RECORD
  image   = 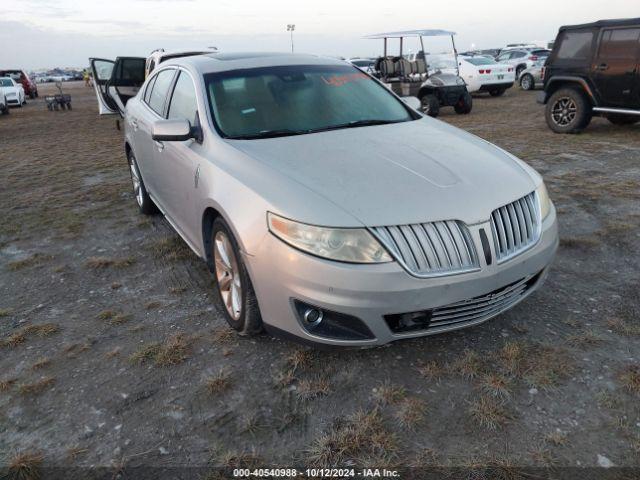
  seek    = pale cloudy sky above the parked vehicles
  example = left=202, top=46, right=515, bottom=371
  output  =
left=0, top=0, right=639, bottom=69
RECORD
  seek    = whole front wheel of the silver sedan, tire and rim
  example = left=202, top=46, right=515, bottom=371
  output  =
left=209, top=217, right=262, bottom=335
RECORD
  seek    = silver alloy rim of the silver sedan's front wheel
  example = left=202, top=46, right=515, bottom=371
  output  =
left=213, top=232, right=242, bottom=320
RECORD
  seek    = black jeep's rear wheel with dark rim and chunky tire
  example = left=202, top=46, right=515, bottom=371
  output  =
left=545, top=88, right=593, bottom=133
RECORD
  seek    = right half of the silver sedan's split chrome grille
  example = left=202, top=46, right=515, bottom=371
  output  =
left=491, top=192, right=540, bottom=262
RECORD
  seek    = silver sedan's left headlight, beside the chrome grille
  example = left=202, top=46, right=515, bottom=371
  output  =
left=267, top=212, right=393, bottom=263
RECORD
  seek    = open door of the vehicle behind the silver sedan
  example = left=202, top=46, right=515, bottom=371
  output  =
left=89, top=57, right=146, bottom=116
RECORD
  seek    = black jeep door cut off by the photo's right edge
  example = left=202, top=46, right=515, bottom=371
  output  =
left=592, top=27, right=640, bottom=108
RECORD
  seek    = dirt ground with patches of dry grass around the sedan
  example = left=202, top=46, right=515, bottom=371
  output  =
left=0, top=79, right=640, bottom=478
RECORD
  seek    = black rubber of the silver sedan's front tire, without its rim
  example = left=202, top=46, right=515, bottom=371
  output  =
left=210, top=217, right=263, bottom=336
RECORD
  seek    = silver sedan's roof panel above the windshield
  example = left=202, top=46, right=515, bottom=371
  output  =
left=162, top=52, right=350, bottom=74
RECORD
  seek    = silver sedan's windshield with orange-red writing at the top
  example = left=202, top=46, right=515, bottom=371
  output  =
left=204, top=65, right=418, bottom=139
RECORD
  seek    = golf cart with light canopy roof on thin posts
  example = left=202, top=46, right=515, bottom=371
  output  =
left=364, top=30, right=473, bottom=117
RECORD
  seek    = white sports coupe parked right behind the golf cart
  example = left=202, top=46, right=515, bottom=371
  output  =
left=427, top=55, right=516, bottom=97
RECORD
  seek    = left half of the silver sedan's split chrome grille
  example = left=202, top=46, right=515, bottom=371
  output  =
left=372, top=220, right=479, bottom=277
